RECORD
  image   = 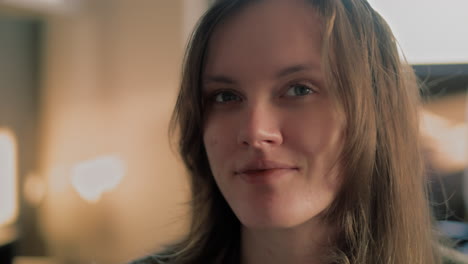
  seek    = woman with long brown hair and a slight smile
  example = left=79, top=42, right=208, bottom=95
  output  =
left=133, top=0, right=462, bottom=264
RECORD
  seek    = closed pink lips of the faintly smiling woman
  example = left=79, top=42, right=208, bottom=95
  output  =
left=235, top=159, right=299, bottom=183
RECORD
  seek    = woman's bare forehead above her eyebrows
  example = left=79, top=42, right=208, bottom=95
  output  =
left=204, top=0, right=322, bottom=78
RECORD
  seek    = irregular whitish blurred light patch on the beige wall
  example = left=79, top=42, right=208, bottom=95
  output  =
left=71, top=156, right=126, bottom=203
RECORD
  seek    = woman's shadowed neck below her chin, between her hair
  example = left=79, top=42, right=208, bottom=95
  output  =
left=241, top=218, right=333, bottom=264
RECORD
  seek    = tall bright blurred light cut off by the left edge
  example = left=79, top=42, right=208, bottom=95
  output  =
left=0, top=129, right=18, bottom=226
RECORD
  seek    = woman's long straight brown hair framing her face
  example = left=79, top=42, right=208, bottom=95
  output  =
left=165, top=0, right=440, bottom=264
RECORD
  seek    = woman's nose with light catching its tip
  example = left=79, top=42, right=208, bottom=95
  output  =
left=237, top=102, right=283, bottom=148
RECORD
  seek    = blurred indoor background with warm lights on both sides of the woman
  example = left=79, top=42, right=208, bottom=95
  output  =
left=0, top=0, right=468, bottom=264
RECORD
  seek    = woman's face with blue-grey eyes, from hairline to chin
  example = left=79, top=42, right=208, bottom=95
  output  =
left=203, top=0, right=345, bottom=228
